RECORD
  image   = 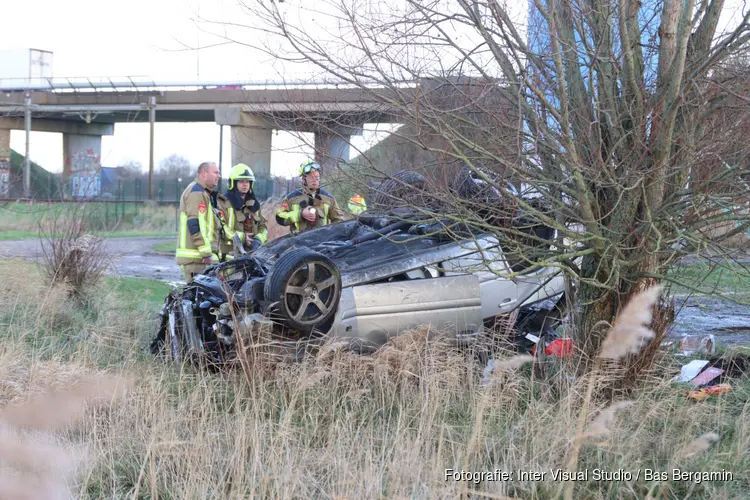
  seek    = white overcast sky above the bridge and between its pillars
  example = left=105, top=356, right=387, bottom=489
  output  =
left=0, top=0, right=742, bottom=179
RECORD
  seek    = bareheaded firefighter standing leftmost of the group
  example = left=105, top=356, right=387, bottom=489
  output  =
left=175, top=162, right=219, bottom=281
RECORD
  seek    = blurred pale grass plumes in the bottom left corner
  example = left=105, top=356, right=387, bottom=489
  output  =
left=0, top=351, right=128, bottom=500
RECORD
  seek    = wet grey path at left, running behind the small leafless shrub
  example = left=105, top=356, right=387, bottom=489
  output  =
left=0, top=238, right=182, bottom=283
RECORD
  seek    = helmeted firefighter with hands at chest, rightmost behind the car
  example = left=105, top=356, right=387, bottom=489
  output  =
left=276, top=161, right=343, bottom=233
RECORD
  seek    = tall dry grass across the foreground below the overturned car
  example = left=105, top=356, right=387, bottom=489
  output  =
left=0, top=263, right=750, bottom=499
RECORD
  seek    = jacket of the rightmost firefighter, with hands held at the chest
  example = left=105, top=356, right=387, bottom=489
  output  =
left=276, top=188, right=344, bottom=233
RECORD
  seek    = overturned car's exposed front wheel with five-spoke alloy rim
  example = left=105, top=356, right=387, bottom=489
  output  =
left=263, top=248, right=341, bottom=332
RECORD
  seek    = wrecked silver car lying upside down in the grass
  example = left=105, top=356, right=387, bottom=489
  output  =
left=151, top=199, right=576, bottom=365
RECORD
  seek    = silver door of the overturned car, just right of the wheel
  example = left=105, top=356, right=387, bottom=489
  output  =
left=332, top=274, right=482, bottom=351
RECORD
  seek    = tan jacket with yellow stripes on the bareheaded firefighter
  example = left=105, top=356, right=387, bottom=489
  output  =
left=175, top=179, right=219, bottom=266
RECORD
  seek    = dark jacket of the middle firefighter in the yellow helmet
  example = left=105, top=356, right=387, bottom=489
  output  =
left=217, top=190, right=268, bottom=260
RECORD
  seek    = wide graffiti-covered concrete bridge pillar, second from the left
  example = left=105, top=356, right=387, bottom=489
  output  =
left=62, top=134, right=102, bottom=198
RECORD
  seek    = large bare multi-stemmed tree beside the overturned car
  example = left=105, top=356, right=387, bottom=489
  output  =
left=207, top=0, right=750, bottom=352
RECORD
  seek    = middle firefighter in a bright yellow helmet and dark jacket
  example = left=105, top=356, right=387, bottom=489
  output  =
left=217, top=163, right=268, bottom=260
